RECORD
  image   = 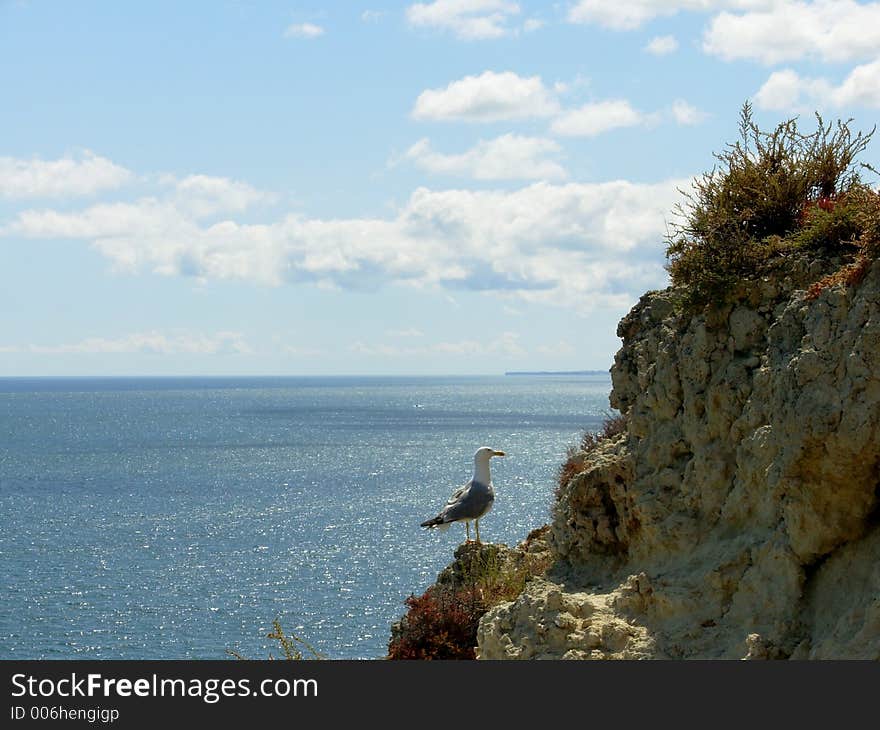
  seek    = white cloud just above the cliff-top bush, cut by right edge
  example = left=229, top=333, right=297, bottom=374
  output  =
left=755, top=60, right=880, bottom=112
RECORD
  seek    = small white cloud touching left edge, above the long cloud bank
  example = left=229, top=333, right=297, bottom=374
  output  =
left=0, top=150, right=132, bottom=199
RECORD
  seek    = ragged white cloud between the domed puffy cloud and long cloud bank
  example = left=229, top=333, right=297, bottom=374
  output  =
left=405, top=134, right=566, bottom=180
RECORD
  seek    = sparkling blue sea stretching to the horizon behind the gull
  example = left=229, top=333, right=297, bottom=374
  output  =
left=0, top=375, right=611, bottom=659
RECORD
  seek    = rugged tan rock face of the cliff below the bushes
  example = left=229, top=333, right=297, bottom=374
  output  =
left=478, top=262, right=880, bottom=659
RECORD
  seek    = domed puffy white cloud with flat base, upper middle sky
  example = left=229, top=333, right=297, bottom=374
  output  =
left=412, top=71, right=559, bottom=122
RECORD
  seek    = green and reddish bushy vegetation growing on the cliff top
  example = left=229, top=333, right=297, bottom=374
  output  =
left=666, top=103, right=880, bottom=306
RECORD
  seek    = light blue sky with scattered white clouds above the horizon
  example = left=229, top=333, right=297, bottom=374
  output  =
left=0, top=0, right=880, bottom=375
